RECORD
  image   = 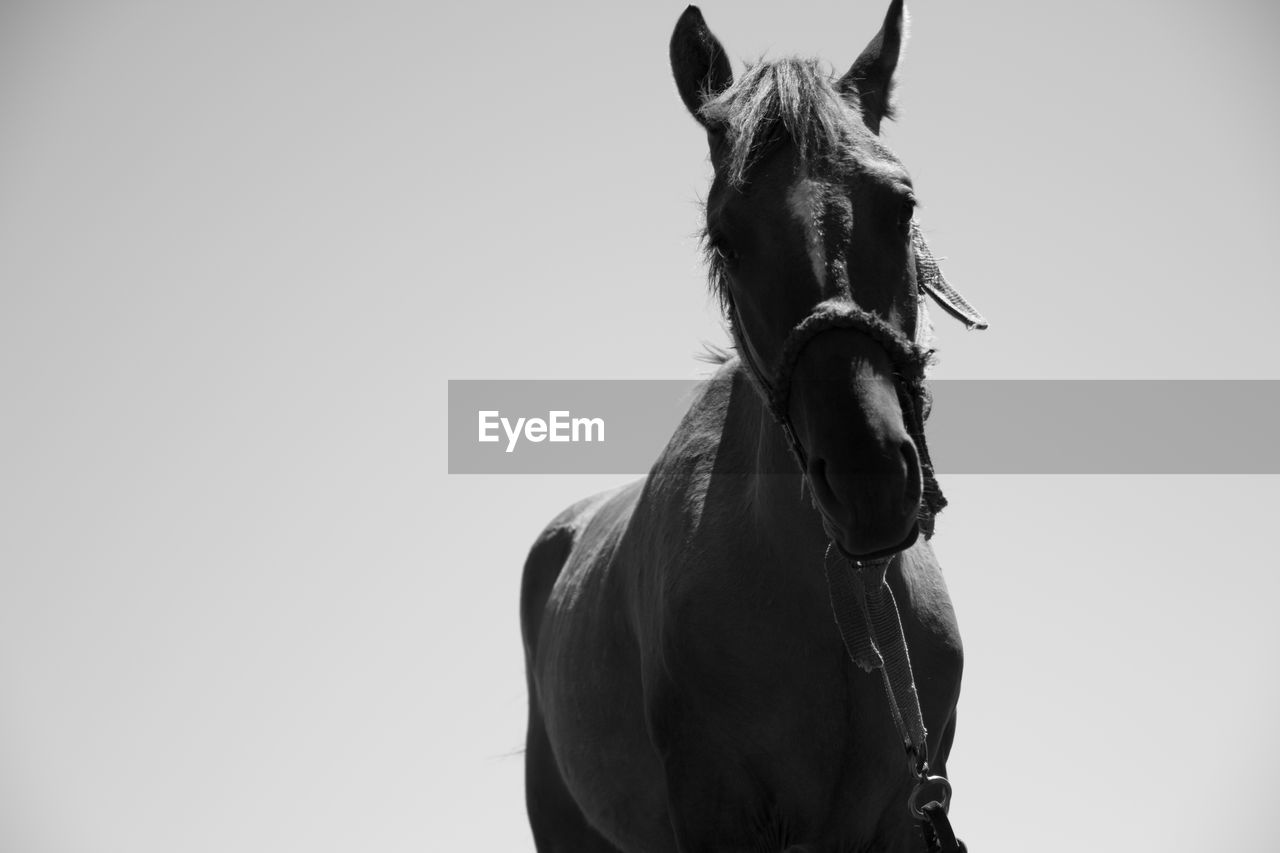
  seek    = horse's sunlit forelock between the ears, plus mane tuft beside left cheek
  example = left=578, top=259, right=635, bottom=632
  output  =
left=699, top=56, right=861, bottom=311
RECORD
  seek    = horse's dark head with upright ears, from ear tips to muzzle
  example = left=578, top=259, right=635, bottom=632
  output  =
left=671, top=0, right=977, bottom=557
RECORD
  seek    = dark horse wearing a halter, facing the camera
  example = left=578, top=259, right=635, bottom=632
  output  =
left=520, top=0, right=986, bottom=853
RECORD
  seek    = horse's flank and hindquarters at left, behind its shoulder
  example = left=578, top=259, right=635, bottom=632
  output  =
left=521, top=482, right=673, bottom=850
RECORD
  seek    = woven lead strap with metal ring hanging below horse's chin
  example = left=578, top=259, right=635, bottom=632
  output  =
left=824, top=543, right=965, bottom=853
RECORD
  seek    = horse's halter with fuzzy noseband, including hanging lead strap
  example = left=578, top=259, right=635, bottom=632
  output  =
left=730, top=220, right=987, bottom=853
